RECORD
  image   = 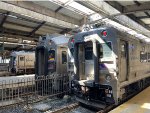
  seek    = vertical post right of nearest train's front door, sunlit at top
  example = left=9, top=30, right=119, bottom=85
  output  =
left=93, top=40, right=99, bottom=83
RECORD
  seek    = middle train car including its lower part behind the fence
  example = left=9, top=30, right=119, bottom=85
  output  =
left=35, top=35, right=69, bottom=93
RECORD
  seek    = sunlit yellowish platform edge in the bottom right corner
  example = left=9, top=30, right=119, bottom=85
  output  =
left=109, top=87, right=150, bottom=113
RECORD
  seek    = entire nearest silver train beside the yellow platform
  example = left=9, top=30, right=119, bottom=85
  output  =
left=72, top=26, right=150, bottom=109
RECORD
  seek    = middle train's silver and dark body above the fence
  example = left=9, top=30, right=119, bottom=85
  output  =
left=36, top=35, right=69, bottom=76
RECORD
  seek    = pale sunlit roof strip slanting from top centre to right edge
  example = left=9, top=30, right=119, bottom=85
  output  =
left=77, top=0, right=150, bottom=37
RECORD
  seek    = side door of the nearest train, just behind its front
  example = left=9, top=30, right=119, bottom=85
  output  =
left=120, top=40, right=128, bottom=82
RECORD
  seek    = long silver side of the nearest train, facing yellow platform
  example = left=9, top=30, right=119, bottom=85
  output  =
left=117, top=33, right=150, bottom=103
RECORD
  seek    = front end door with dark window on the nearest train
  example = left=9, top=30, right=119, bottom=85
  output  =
left=84, top=42, right=94, bottom=80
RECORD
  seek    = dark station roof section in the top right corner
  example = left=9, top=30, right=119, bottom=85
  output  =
left=106, top=0, right=150, bottom=34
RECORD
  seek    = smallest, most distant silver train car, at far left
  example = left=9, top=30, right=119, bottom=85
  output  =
left=9, top=51, right=35, bottom=74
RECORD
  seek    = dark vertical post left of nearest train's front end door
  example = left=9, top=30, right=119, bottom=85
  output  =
left=74, top=44, right=79, bottom=80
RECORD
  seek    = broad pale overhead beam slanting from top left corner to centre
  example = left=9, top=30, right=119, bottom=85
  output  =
left=0, top=1, right=80, bottom=28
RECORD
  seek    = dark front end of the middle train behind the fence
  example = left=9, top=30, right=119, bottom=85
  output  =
left=35, top=36, right=56, bottom=77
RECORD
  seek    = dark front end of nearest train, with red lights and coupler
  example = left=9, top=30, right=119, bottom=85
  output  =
left=72, top=27, right=117, bottom=109
